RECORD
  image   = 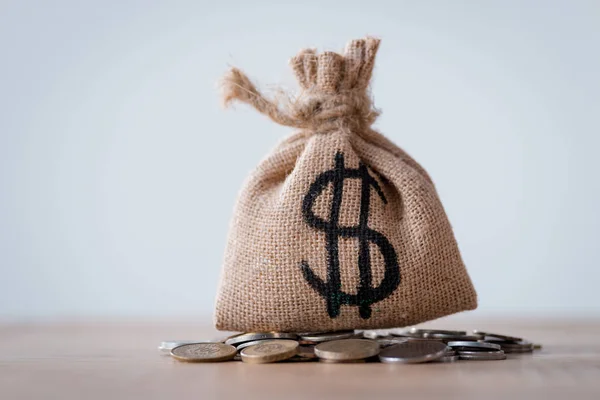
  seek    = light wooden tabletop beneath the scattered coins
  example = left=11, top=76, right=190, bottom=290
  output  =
left=0, top=318, right=600, bottom=400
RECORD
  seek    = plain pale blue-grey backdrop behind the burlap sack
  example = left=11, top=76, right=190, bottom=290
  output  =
left=0, top=0, right=600, bottom=319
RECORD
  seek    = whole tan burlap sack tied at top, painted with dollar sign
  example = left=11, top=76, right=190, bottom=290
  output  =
left=215, top=38, right=477, bottom=332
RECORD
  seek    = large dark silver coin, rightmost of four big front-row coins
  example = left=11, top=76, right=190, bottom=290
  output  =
left=379, top=340, right=448, bottom=364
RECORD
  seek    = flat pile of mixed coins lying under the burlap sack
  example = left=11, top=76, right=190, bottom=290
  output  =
left=158, top=328, right=541, bottom=364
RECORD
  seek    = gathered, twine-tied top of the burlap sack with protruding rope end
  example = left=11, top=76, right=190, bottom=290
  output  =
left=223, top=38, right=380, bottom=133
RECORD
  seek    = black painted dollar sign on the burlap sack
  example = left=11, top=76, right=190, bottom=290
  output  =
left=300, top=152, right=400, bottom=319
